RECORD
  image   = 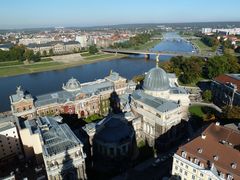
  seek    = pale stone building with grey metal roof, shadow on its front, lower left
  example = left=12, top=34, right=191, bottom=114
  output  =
left=17, top=116, right=87, bottom=180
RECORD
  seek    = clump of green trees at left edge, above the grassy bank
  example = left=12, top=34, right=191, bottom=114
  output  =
left=0, top=45, right=41, bottom=61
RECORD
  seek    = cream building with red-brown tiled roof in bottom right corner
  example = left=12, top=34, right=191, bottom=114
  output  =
left=172, top=122, right=240, bottom=180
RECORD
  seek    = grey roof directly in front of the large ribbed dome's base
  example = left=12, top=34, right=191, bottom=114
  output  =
left=132, top=90, right=179, bottom=112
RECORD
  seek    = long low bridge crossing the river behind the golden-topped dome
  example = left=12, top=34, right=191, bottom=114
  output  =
left=102, top=49, right=210, bottom=59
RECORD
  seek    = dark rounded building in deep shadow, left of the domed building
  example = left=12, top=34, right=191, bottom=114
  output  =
left=83, top=113, right=137, bottom=172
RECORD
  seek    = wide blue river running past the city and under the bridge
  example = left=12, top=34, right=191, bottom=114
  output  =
left=0, top=32, right=193, bottom=112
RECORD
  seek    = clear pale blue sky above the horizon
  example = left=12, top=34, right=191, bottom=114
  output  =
left=0, top=0, right=240, bottom=29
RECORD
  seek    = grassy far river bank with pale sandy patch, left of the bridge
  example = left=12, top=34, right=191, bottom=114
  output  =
left=0, top=40, right=160, bottom=78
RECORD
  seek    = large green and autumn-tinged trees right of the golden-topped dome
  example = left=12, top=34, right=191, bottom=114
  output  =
left=161, top=54, right=240, bottom=84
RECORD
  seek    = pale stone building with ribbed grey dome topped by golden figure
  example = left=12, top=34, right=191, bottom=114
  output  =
left=127, top=57, right=190, bottom=146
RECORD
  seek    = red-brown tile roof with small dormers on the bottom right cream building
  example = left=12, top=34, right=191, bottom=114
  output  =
left=177, top=123, right=240, bottom=179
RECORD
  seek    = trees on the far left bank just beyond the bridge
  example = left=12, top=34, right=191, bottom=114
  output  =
left=111, top=33, right=152, bottom=48
